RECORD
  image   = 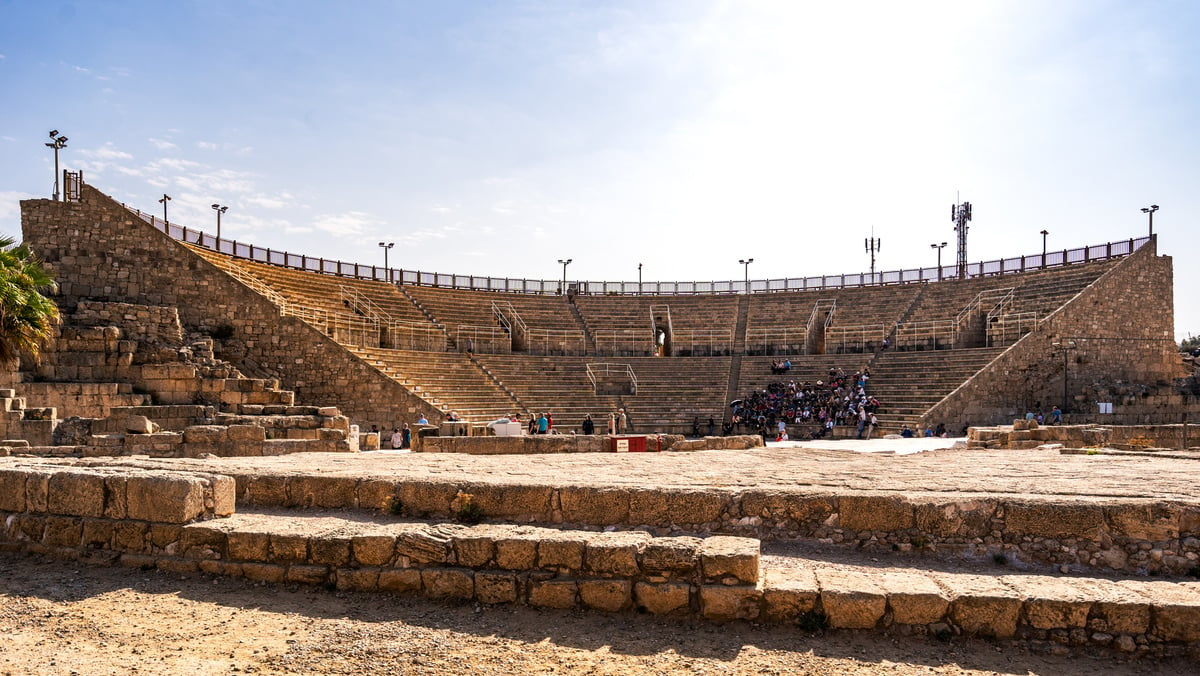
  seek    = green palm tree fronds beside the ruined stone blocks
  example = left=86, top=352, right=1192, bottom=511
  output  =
left=0, top=237, right=61, bottom=364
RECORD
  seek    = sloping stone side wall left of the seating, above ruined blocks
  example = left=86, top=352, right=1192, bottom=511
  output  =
left=22, top=185, right=443, bottom=429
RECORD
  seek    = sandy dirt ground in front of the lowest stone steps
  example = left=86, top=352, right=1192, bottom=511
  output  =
left=0, top=554, right=1198, bottom=676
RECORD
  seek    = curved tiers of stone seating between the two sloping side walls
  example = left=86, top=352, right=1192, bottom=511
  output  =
left=180, top=245, right=1120, bottom=431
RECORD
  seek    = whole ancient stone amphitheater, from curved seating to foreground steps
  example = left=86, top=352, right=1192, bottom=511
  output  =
left=0, top=185, right=1200, bottom=654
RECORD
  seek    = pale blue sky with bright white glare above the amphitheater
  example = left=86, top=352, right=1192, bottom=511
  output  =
left=0, top=0, right=1200, bottom=336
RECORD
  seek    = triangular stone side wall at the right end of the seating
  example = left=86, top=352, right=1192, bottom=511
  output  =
left=920, top=240, right=1183, bottom=429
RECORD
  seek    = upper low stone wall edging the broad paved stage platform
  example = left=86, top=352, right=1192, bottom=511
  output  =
left=211, top=473, right=1200, bottom=575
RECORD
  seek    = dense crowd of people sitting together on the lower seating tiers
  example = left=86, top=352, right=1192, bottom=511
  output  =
left=726, top=364, right=880, bottom=439
